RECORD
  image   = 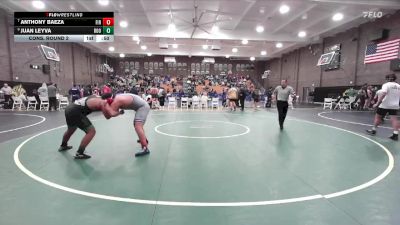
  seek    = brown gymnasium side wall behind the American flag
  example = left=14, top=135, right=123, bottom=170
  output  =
left=264, top=11, right=400, bottom=97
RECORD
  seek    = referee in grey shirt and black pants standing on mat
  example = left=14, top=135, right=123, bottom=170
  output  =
left=274, top=80, right=294, bottom=130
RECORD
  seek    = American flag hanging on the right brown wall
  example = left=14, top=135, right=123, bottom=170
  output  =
left=364, top=39, right=400, bottom=64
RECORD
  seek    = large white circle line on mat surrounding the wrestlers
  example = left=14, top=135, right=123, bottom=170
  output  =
left=13, top=114, right=394, bottom=207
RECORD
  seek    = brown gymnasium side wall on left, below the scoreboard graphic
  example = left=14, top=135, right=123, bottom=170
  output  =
left=0, top=9, right=110, bottom=93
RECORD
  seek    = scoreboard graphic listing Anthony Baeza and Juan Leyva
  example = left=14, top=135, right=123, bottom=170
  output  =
left=14, top=12, right=114, bottom=42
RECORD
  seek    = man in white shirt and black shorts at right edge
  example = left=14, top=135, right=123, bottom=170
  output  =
left=367, top=74, right=400, bottom=141
